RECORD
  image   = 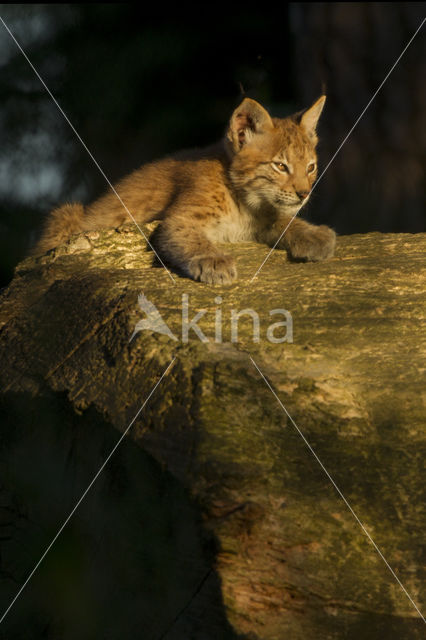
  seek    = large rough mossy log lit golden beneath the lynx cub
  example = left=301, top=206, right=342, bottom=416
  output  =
left=0, top=222, right=426, bottom=640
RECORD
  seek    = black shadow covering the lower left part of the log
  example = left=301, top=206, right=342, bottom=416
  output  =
left=0, top=393, right=238, bottom=640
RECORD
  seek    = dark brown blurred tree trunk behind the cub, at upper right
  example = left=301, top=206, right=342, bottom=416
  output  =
left=290, top=2, right=426, bottom=232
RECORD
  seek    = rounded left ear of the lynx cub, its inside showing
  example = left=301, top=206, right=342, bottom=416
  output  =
left=226, top=98, right=274, bottom=151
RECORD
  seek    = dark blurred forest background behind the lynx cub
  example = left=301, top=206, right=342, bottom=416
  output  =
left=0, top=2, right=426, bottom=285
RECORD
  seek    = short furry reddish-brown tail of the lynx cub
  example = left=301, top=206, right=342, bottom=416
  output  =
left=32, top=204, right=84, bottom=255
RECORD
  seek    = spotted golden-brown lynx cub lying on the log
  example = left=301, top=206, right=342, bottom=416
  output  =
left=36, top=96, right=336, bottom=284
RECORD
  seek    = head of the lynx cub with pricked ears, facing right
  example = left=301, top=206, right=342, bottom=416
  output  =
left=226, top=96, right=325, bottom=215
